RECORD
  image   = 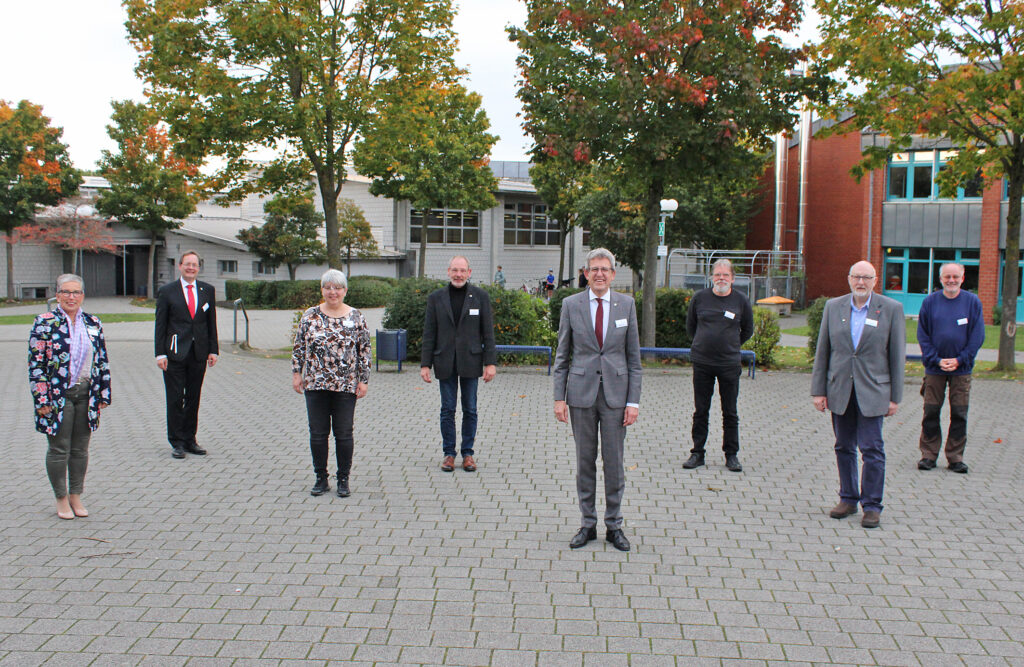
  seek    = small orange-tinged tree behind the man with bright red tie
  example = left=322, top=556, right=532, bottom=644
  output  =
left=96, top=100, right=199, bottom=297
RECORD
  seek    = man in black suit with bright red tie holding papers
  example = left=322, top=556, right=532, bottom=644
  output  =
left=155, top=250, right=219, bottom=459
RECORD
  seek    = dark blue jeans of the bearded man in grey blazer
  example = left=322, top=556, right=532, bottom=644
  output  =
left=833, top=390, right=886, bottom=512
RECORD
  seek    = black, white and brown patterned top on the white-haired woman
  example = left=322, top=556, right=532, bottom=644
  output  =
left=292, top=305, right=371, bottom=393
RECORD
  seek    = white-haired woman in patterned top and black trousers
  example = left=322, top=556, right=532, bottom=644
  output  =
left=292, top=268, right=370, bottom=498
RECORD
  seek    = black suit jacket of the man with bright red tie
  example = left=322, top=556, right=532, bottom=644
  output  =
left=154, top=280, right=219, bottom=362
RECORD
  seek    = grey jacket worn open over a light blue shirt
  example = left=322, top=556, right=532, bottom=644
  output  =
left=811, top=294, right=906, bottom=417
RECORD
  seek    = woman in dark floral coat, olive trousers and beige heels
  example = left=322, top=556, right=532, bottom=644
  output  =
left=29, top=274, right=111, bottom=518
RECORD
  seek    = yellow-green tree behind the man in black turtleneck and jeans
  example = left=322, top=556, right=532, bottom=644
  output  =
left=353, top=79, right=498, bottom=278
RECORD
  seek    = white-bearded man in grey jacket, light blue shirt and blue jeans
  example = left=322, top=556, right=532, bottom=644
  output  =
left=811, top=261, right=906, bottom=528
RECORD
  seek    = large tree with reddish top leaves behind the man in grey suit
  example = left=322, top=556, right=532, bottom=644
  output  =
left=511, top=0, right=813, bottom=345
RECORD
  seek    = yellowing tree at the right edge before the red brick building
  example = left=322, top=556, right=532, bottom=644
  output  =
left=815, top=0, right=1024, bottom=371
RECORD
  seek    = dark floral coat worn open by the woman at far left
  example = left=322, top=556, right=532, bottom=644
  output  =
left=29, top=309, right=111, bottom=435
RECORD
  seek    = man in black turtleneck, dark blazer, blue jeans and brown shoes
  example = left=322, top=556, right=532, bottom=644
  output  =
left=420, top=255, right=498, bottom=472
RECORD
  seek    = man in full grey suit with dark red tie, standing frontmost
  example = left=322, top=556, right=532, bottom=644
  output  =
left=554, top=248, right=642, bottom=551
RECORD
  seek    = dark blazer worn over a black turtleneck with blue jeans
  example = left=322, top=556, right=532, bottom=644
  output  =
left=420, top=285, right=498, bottom=380
